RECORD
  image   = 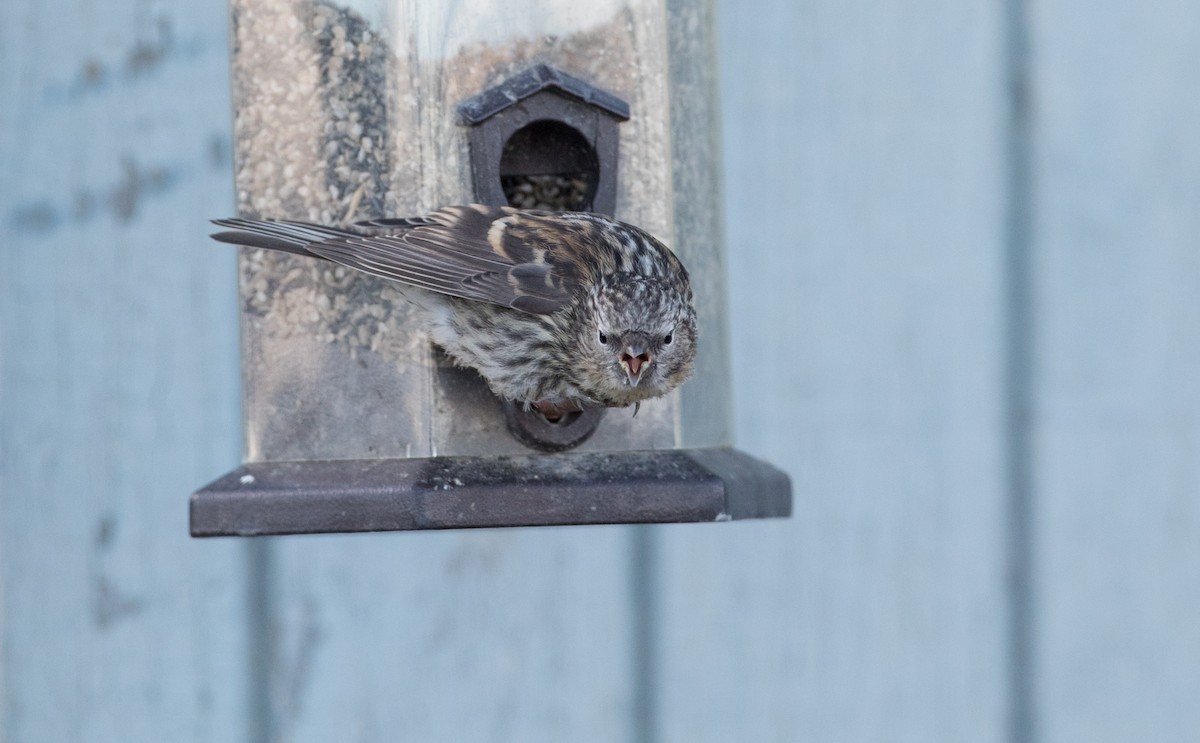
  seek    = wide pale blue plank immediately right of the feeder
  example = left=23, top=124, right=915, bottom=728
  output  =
left=656, top=1, right=1007, bottom=743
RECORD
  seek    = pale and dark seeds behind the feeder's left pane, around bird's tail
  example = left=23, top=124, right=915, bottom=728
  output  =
left=233, top=0, right=410, bottom=355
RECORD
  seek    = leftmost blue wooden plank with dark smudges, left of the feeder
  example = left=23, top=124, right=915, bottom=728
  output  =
left=0, top=0, right=250, bottom=743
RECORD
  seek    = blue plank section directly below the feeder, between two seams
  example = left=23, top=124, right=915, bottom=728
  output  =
left=259, top=528, right=635, bottom=742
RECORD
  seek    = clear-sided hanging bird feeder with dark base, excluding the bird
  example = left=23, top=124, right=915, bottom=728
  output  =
left=191, top=0, right=791, bottom=537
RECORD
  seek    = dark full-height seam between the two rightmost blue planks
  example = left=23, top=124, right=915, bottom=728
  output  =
left=1003, top=0, right=1038, bottom=743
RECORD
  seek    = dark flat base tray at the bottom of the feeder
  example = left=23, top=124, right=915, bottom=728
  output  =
left=191, top=448, right=792, bottom=537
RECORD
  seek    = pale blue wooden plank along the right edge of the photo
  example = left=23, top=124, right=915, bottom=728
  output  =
left=1030, top=0, right=1200, bottom=743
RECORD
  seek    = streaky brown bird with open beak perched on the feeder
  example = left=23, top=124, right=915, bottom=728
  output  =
left=212, top=204, right=696, bottom=420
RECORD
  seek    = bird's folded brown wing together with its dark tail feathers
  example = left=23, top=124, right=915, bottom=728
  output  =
left=214, top=205, right=576, bottom=314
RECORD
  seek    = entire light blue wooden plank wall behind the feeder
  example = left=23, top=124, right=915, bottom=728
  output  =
left=0, top=0, right=1200, bottom=743
